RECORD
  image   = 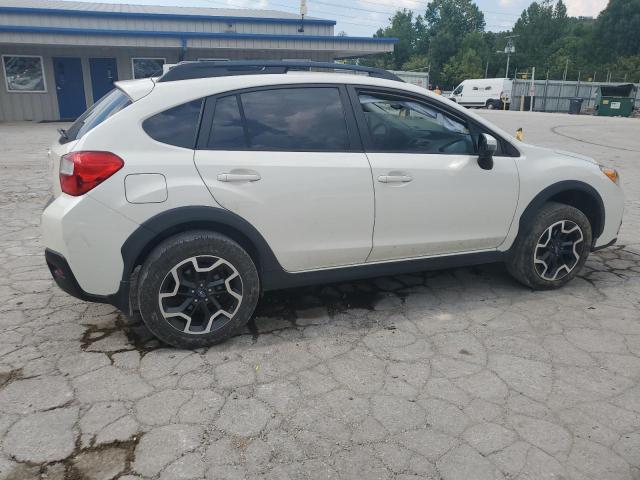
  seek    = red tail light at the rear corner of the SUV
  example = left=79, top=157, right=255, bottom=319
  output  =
left=60, top=152, right=124, bottom=197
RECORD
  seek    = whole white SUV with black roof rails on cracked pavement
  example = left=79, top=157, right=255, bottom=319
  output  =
left=42, top=62, right=624, bottom=348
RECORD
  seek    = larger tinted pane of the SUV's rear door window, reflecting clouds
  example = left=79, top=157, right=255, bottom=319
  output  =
left=240, top=87, right=349, bottom=151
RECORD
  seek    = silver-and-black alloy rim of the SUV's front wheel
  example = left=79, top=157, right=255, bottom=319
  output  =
left=533, top=220, right=584, bottom=281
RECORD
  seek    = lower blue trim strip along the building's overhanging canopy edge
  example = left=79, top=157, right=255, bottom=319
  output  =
left=0, top=25, right=398, bottom=43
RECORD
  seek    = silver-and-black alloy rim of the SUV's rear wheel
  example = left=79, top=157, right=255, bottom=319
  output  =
left=158, top=255, right=243, bottom=334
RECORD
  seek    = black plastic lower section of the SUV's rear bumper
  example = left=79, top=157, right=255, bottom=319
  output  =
left=44, top=248, right=129, bottom=313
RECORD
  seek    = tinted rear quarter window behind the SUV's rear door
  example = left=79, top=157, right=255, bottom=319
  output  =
left=142, top=99, right=202, bottom=148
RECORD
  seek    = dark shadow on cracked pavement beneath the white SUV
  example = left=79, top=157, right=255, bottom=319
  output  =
left=105, top=264, right=526, bottom=353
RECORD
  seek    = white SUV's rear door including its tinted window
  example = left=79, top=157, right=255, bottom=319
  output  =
left=195, top=85, right=374, bottom=272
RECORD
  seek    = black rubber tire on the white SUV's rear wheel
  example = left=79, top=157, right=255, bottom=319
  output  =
left=138, top=230, right=260, bottom=349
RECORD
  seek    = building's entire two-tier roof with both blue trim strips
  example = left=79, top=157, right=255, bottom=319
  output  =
left=0, top=0, right=397, bottom=58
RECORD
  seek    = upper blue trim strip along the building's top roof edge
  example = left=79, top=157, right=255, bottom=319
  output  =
left=0, top=7, right=336, bottom=25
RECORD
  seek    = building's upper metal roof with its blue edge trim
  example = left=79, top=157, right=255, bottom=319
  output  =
left=0, top=0, right=336, bottom=25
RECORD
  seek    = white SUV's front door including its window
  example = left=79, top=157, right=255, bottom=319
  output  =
left=354, top=90, right=518, bottom=262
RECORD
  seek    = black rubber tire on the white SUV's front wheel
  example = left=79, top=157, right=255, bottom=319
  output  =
left=506, top=202, right=592, bottom=290
